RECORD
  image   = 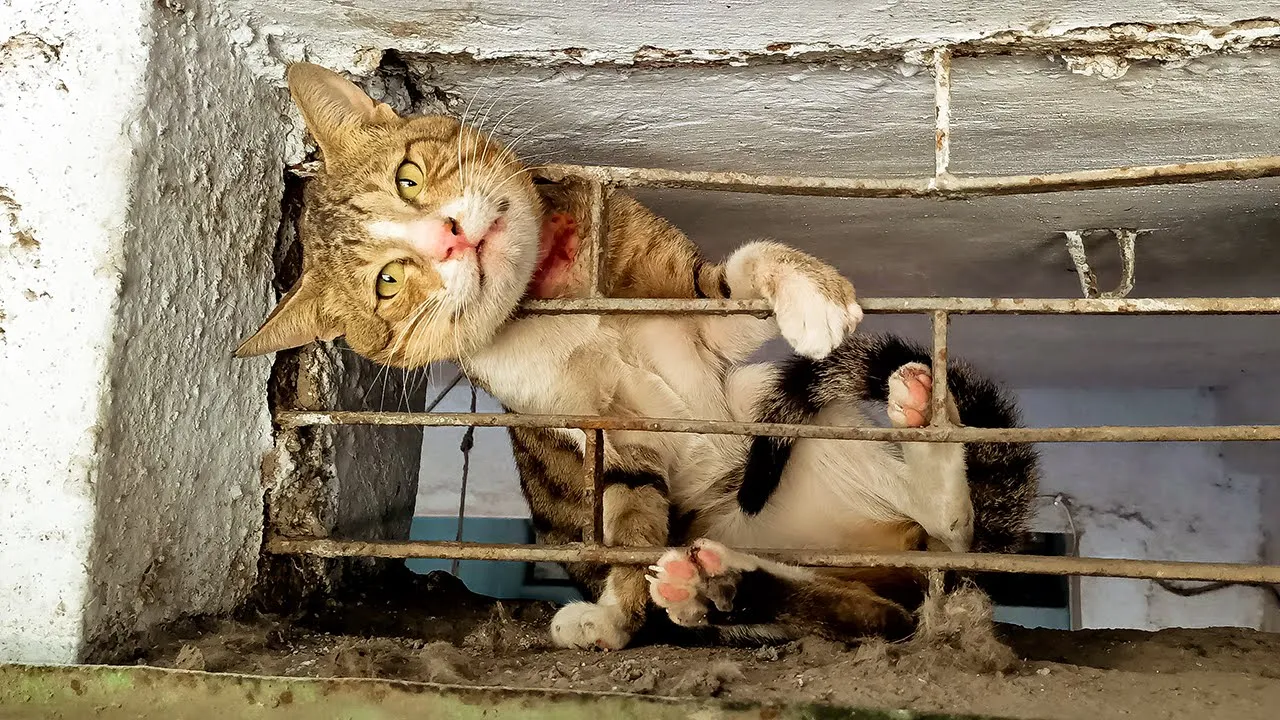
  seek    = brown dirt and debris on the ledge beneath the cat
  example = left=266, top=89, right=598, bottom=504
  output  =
left=132, top=573, right=1280, bottom=720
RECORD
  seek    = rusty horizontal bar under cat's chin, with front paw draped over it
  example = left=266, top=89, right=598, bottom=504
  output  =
left=521, top=297, right=1280, bottom=318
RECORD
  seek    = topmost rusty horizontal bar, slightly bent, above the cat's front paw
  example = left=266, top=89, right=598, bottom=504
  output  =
left=538, top=155, right=1280, bottom=199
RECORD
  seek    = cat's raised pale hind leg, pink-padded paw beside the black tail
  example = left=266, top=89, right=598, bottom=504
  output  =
left=887, top=363, right=973, bottom=552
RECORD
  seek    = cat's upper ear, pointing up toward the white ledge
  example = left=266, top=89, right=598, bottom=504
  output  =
left=285, top=63, right=397, bottom=161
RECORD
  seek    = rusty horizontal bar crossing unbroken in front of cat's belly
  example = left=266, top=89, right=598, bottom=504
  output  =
left=275, top=410, right=1280, bottom=442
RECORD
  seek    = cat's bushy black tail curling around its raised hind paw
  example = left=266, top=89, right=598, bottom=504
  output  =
left=737, top=333, right=1039, bottom=552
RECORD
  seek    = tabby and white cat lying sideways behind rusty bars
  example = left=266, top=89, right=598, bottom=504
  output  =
left=236, top=63, right=1038, bottom=648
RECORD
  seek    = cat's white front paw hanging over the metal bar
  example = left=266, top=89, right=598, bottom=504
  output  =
left=773, top=268, right=863, bottom=360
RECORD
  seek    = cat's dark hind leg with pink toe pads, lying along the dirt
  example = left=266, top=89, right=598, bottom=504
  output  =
left=649, top=539, right=914, bottom=639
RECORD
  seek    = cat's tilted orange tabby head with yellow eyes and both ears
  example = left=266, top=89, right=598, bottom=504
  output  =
left=236, top=63, right=543, bottom=368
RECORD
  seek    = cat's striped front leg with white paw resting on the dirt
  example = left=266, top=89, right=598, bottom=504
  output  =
left=552, top=458, right=669, bottom=650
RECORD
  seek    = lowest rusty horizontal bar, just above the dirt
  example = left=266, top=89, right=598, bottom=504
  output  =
left=266, top=536, right=1280, bottom=583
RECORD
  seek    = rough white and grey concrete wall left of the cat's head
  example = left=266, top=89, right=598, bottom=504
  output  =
left=0, top=0, right=283, bottom=662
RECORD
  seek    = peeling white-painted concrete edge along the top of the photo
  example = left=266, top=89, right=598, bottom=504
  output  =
left=220, top=0, right=1280, bottom=74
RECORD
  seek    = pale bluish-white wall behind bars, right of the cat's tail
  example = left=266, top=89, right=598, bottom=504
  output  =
left=1019, top=389, right=1270, bottom=629
